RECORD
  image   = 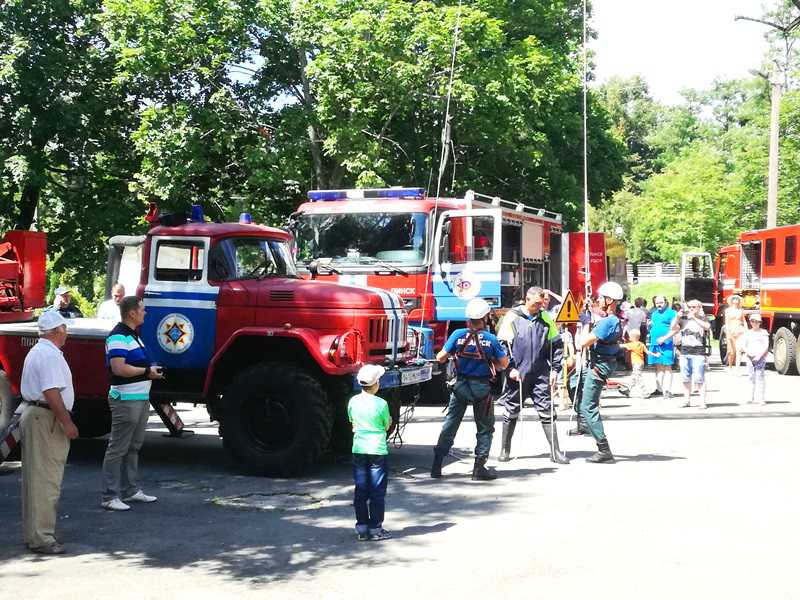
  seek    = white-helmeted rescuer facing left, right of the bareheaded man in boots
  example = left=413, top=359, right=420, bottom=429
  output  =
left=580, top=281, right=624, bottom=463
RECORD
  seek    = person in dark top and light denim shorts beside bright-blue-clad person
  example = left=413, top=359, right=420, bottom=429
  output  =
left=657, top=300, right=711, bottom=408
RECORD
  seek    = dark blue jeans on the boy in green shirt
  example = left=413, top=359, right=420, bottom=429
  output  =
left=353, top=454, right=389, bottom=533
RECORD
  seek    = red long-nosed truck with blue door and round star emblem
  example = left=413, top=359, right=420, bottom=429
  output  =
left=0, top=213, right=431, bottom=476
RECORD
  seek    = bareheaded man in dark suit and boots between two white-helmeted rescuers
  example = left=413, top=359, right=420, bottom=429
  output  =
left=498, top=287, right=569, bottom=465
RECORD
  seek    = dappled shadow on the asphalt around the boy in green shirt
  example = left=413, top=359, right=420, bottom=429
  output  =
left=0, top=438, right=532, bottom=585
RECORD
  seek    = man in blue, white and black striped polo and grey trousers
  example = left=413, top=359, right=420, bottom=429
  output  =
left=101, top=296, right=164, bottom=510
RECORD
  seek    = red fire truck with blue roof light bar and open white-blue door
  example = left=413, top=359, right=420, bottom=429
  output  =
left=290, top=188, right=626, bottom=392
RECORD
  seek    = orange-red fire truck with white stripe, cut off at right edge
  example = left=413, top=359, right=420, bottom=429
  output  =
left=684, top=225, right=800, bottom=375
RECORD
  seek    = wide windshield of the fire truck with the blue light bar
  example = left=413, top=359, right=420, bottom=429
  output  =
left=294, top=213, right=428, bottom=266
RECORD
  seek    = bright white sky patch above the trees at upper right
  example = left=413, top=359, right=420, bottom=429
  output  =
left=592, top=0, right=767, bottom=104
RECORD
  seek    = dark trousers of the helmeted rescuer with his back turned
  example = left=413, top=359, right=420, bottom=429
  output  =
left=434, top=379, right=494, bottom=458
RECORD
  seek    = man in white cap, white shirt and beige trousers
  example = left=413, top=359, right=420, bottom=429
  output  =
left=20, top=310, right=78, bottom=554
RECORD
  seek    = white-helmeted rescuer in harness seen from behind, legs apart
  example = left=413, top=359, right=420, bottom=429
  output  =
left=431, top=298, right=508, bottom=481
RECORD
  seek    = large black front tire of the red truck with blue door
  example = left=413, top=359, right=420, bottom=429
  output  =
left=222, top=363, right=333, bottom=477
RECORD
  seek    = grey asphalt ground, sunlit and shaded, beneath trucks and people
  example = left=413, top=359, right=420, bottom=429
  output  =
left=0, top=358, right=800, bottom=600
